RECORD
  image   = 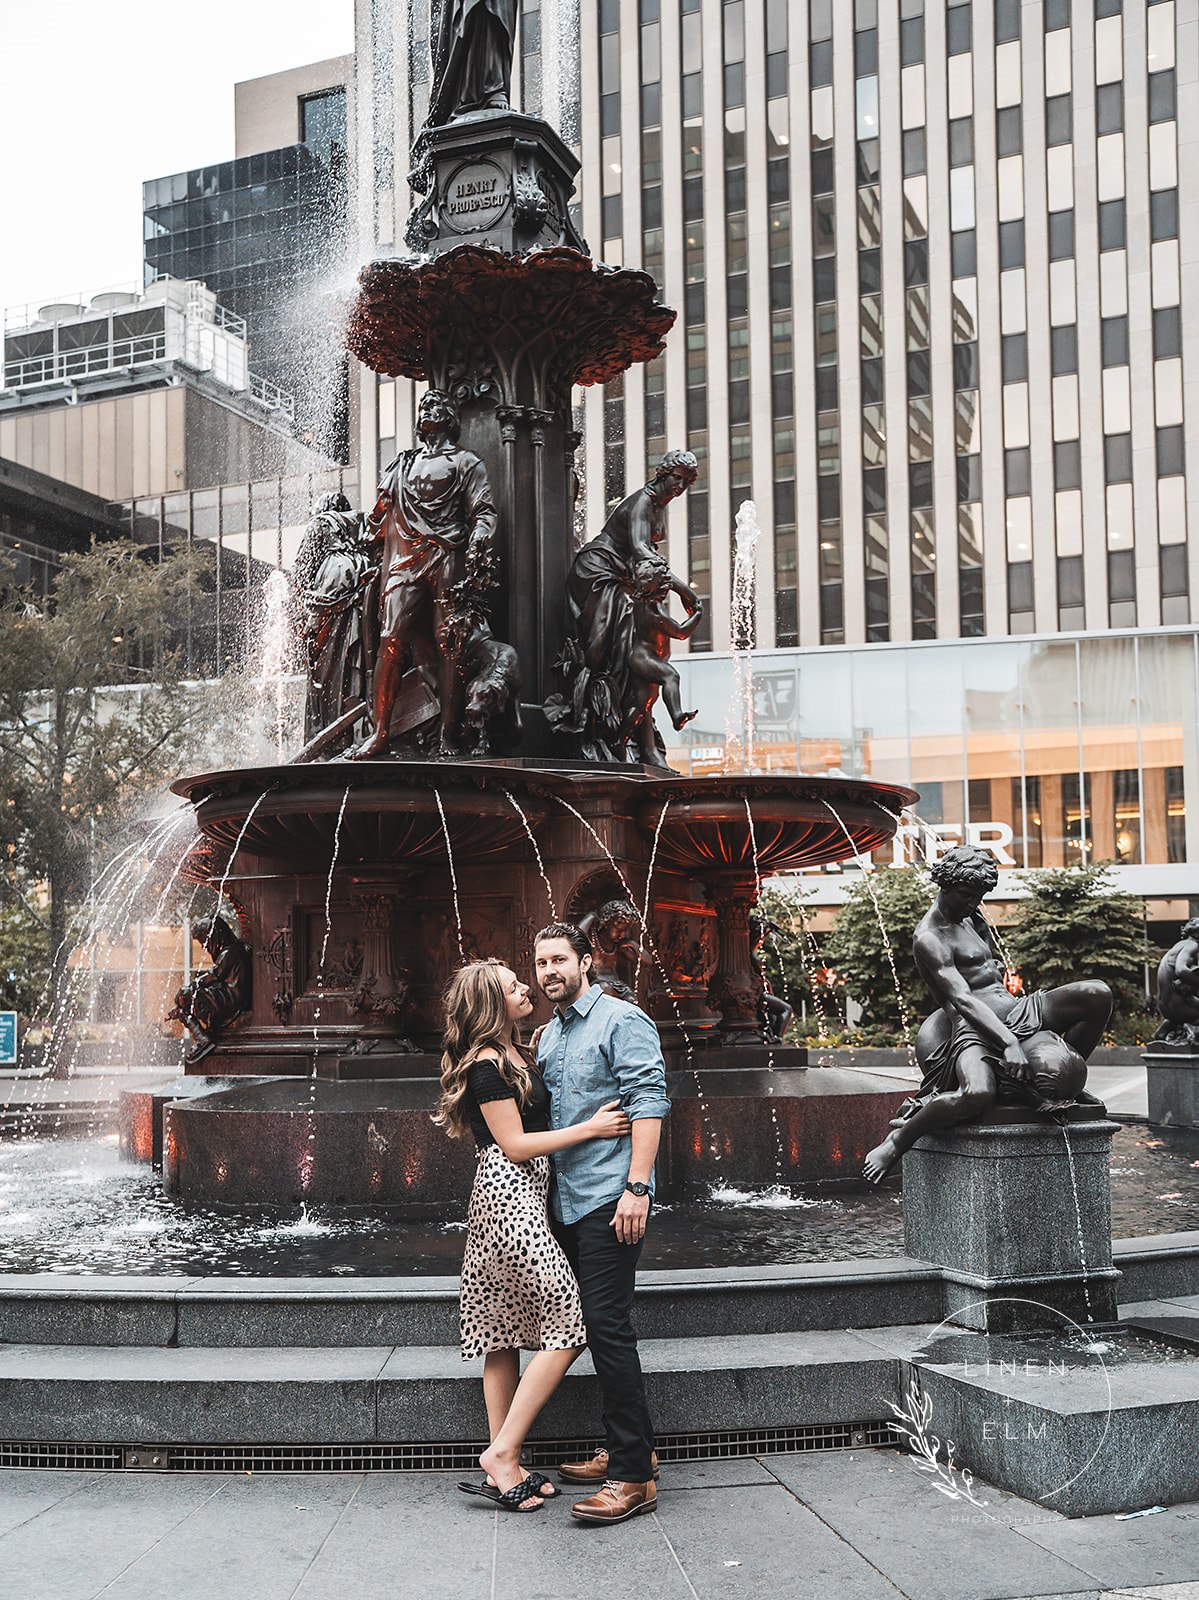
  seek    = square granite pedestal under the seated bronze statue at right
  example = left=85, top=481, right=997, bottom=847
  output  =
left=903, top=1106, right=1119, bottom=1333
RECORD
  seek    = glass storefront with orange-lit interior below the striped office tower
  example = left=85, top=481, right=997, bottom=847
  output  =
left=668, top=627, right=1199, bottom=898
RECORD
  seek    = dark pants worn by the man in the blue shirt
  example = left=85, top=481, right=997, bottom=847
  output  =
left=554, top=1200, right=653, bottom=1483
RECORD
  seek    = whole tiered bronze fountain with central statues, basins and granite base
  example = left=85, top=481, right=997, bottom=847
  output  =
left=140, top=0, right=914, bottom=1206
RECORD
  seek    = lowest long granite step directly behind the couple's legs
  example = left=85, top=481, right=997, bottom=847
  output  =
left=0, top=1330, right=901, bottom=1446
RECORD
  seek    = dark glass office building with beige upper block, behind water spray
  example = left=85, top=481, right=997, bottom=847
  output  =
left=142, top=58, right=354, bottom=461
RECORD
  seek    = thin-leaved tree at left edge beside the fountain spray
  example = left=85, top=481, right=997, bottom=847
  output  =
left=0, top=541, right=195, bottom=1004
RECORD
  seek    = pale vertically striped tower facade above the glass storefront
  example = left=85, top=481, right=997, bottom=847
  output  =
left=579, top=0, right=1199, bottom=650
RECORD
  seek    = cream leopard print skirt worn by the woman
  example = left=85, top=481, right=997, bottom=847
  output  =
left=459, top=1144, right=587, bottom=1362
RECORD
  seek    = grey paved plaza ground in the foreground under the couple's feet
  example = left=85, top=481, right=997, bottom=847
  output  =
left=0, top=1450, right=1199, bottom=1600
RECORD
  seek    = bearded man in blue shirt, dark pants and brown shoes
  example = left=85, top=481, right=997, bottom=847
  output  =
left=533, top=922, right=671, bottom=1523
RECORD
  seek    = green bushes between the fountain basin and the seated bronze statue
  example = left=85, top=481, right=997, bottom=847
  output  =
left=762, top=867, right=935, bottom=1038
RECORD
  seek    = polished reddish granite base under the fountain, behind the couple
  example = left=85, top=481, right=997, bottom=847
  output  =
left=152, top=1051, right=896, bottom=1218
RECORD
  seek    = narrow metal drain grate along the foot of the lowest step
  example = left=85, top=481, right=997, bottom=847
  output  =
left=0, top=1422, right=898, bottom=1472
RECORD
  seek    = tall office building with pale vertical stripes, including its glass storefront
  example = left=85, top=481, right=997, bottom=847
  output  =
left=357, top=0, right=1199, bottom=928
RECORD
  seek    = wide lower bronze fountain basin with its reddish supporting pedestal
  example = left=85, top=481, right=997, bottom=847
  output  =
left=173, top=760, right=912, bottom=1077
